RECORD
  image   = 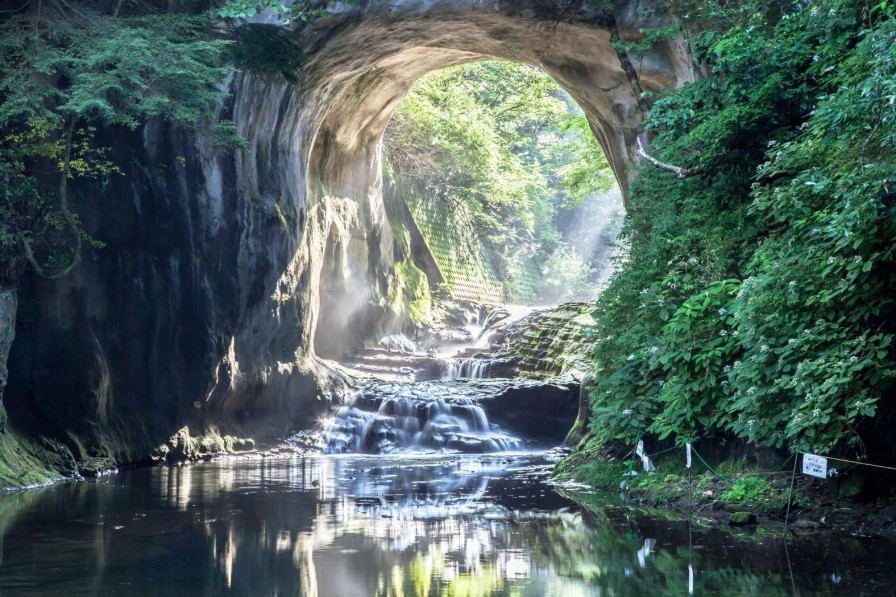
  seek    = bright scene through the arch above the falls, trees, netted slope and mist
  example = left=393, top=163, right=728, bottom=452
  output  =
left=383, top=62, right=623, bottom=306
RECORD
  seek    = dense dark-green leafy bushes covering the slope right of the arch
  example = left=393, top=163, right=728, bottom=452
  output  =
left=591, top=0, right=896, bottom=452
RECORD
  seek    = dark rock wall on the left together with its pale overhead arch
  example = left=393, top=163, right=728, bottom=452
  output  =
left=5, top=0, right=693, bottom=459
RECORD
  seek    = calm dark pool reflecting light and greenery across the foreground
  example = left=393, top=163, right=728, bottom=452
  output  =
left=0, top=454, right=896, bottom=597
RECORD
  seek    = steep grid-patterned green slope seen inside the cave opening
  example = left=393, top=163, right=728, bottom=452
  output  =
left=404, top=193, right=504, bottom=303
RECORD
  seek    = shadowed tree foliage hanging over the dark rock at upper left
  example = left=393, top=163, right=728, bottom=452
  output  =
left=0, top=8, right=234, bottom=278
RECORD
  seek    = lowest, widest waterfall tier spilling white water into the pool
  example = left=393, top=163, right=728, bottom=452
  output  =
left=325, top=383, right=523, bottom=454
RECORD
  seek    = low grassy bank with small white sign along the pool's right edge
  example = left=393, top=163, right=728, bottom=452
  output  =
left=553, top=438, right=896, bottom=536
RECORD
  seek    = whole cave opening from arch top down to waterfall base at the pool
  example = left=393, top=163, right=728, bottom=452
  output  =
left=316, top=61, right=624, bottom=453
